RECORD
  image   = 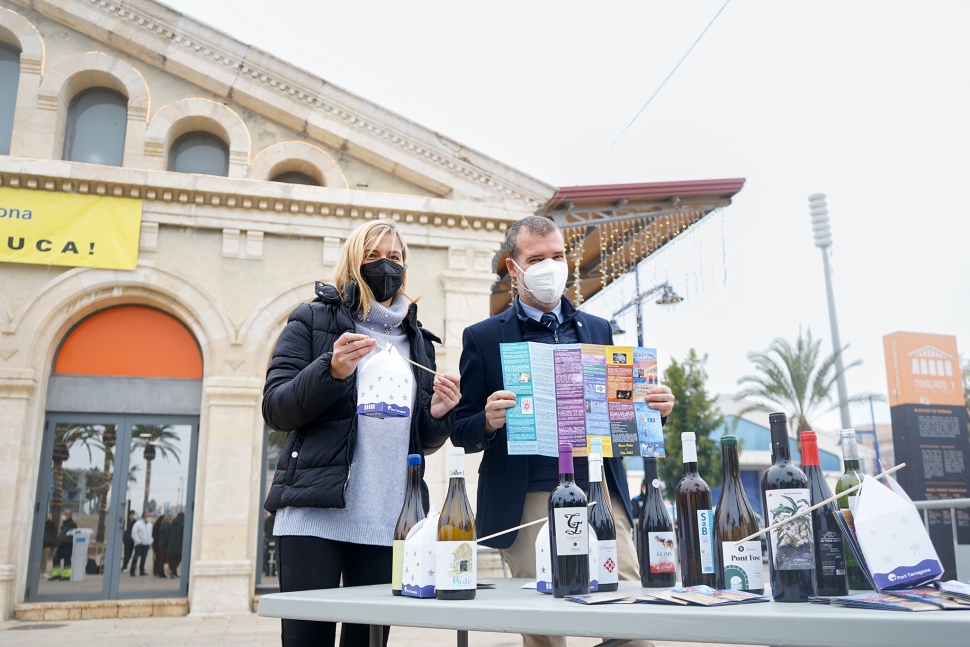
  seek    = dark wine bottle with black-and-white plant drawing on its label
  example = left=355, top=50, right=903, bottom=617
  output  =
left=761, top=413, right=815, bottom=602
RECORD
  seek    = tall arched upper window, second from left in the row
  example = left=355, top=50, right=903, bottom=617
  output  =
left=64, top=88, right=128, bottom=166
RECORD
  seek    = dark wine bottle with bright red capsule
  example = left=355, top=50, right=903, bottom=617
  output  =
left=802, top=431, right=849, bottom=595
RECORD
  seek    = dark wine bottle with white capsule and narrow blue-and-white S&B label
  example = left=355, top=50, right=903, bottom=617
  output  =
left=676, top=431, right=717, bottom=587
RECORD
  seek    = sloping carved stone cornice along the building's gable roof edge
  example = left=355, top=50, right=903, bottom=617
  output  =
left=13, top=0, right=554, bottom=211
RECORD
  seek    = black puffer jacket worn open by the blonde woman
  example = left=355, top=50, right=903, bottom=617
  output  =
left=263, top=282, right=455, bottom=512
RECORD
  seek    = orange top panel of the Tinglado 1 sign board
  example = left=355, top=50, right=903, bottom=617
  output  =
left=882, top=332, right=964, bottom=407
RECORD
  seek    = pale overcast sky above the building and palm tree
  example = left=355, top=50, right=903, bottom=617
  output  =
left=166, top=0, right=970, bottom=436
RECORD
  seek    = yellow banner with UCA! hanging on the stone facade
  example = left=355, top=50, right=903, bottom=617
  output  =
left=0, top=189, right=142, bottom=270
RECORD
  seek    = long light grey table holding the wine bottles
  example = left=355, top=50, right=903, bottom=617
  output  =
left=258, top=579, right=970, bottom=647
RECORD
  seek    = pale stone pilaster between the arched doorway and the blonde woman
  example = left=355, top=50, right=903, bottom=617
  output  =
left=189, top=376, right=263, bottom=613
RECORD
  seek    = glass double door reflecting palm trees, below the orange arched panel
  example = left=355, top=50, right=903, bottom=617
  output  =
left=26, top=414, right=198, bottom=601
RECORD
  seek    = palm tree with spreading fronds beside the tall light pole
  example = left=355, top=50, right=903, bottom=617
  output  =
left=738, top=330, right=883, bottom=447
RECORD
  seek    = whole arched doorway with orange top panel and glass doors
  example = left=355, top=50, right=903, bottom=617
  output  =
left=26, top=305, right=202, bottom=601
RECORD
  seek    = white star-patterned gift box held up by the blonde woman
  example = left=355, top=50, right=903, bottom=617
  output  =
left=357, top=346, right=414, bottom=418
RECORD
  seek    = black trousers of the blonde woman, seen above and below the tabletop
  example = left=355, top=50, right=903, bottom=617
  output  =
left=276, top=536, right=392, bottom=647
